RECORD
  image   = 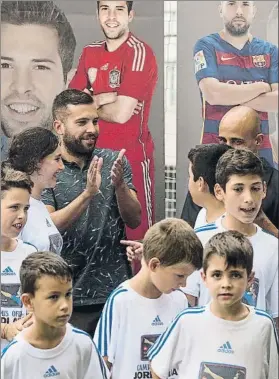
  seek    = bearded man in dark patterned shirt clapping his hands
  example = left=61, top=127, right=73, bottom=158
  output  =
left=43, top=89, right=141, bottom=336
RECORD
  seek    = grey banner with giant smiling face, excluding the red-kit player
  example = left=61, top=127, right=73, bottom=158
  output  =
left=1, top=0, right=165, bottom=223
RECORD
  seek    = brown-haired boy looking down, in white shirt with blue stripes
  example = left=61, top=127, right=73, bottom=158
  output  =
left=94, top=218, right=203, bottom=379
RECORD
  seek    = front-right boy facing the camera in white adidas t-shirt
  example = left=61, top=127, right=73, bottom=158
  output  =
left=148, top=231, right=278, bottom=379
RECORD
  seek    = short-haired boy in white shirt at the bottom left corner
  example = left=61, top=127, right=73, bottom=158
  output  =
left=1, top=252, right=108, bottom=379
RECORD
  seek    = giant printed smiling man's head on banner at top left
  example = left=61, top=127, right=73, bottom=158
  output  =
left=1, top=1, right=76, bottom=159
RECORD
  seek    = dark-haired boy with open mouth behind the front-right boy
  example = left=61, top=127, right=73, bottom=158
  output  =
left=183, top=149, right=278, bottom=330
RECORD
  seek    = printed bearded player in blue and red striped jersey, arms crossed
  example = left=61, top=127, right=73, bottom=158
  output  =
left=194, top=1, right=278, bottom=168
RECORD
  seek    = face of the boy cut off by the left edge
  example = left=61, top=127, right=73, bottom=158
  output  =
left=1, top=188, right=30, bottom=238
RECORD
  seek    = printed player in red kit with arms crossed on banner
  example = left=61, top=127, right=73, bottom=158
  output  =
left=70, top=1, right=157, bottom=243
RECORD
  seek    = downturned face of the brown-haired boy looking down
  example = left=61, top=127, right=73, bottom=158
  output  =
left=149, top=262, right=195, bottom=294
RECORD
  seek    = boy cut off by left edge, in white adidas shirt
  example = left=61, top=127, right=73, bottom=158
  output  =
left=1, top=163, right=37, bottom=350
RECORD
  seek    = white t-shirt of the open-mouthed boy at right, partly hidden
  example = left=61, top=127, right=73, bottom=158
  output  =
left=182, top=216, right=278, bottom=318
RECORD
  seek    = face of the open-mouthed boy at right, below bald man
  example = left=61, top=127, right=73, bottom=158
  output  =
left=215, top=175, right=266, bottom=224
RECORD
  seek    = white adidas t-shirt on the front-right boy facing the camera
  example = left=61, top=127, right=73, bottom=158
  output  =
left=151, top=304, right=278, bottom=379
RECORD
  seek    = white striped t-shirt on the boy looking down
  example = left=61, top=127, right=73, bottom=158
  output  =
left=94, top=281, right=188, bottom=379
